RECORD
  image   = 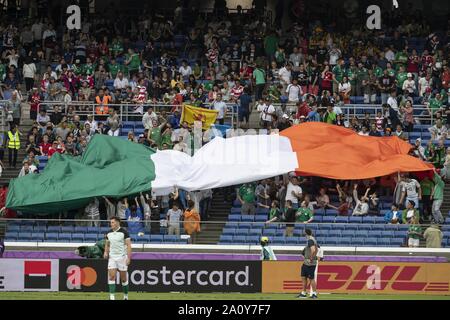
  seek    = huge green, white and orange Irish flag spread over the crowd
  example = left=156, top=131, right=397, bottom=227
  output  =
left=6, top=123, right=433, bottom=213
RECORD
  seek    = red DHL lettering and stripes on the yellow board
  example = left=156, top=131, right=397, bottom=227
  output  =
left=283, top=265, right=449, bottom=292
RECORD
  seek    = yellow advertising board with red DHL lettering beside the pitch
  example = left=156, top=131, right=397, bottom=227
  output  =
left=262, top=261, right=450, bottom=295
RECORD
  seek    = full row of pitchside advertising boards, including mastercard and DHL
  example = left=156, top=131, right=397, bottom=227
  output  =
left=0, top=258, right=450, bottom=295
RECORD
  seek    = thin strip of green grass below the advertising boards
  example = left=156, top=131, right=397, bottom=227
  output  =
left=0, top=292, right=450, bottom=300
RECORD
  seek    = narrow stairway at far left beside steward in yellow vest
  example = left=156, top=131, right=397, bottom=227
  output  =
left=0, top=103, right=33, bottom=185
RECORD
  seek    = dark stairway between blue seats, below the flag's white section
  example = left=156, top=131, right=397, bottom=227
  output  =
left=196, top=190, right=231, bottom=244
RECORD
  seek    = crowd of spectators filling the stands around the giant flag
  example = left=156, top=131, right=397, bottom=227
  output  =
left=0, top=1, right=450, bottom=246
